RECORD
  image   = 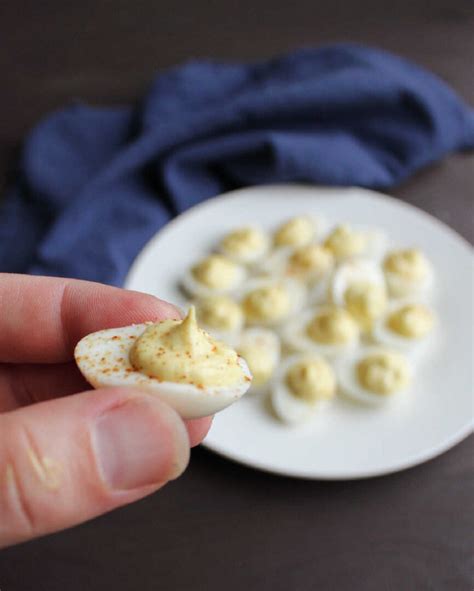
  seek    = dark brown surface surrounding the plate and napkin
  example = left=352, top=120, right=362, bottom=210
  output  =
left=0, top=0, right=474, bottom=591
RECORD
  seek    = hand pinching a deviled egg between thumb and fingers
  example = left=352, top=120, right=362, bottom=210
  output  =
left=0, top=274, right=210, bottom=547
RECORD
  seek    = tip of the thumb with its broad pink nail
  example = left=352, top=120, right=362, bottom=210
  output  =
left=93, top=395, right=189, bottom=490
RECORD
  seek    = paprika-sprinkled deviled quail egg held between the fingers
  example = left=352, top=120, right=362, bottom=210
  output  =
left=74, top=307, right=252, bottom=419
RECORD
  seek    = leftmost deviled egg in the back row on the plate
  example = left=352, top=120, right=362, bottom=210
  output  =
left=219, top=226, right=270, bottom=264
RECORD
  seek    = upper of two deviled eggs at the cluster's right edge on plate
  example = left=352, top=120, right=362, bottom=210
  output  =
left=383, top=248, right=433, bottom=298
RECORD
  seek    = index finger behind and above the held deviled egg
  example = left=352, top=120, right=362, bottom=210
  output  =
left=0, top=273, right=179, bottom=363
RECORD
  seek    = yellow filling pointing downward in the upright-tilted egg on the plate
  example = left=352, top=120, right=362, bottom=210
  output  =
left=344, top=281, right=387, bottom=330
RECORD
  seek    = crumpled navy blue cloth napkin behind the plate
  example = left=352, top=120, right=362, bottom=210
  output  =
left=0, top=45, right=474, bottom=285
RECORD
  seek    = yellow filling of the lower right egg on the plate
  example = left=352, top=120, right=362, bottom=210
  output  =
left=356, top=353, right=410, bottom=396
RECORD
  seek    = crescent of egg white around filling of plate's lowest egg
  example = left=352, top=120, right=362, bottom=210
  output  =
left=271, top=355, right=331, bottom=425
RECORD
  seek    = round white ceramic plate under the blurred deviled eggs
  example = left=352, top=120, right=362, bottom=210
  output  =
left=126, top=185, right=473, bottom=479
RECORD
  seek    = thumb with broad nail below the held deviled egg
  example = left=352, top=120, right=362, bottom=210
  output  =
left=0, top=388, right=189, bottom=547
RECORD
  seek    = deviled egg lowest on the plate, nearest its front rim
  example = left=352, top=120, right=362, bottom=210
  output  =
left=272, top=355, right=337, bottom=424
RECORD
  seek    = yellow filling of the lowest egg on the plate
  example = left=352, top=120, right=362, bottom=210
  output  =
left=286, top=359, right=336, bottom=402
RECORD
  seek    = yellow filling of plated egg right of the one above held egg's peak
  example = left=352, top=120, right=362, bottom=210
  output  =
left=242, top=284, right=291, bottom=322
